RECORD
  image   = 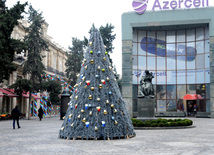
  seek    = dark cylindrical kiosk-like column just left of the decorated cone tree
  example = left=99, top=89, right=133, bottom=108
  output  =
left=60, top=89, right=70, bottom=120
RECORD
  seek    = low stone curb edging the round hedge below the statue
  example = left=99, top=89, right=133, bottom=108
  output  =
left=134, top=125, right=196, bottom=130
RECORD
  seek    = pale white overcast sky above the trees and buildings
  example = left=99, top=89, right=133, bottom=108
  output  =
left=6, top=0, right=214, bottom=74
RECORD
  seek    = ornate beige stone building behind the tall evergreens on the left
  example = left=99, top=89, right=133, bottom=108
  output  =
left=0, top=20, right=67, bottom=117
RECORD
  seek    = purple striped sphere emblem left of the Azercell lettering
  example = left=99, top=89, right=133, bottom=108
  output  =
left=132, top=0, right=148, bottom=14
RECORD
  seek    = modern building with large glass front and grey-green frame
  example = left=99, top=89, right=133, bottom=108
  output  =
left=122, top=7, right=214, bottom=117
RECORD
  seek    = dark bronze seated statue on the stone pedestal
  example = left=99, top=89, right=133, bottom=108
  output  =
left=138, top=70, right=155, bottom=98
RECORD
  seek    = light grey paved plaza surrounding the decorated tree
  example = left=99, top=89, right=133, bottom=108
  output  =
left=0, top=117, right=214, bottom=155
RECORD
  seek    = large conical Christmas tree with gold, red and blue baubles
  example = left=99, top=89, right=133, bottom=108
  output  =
left=59, top=29, right=135, bottom=140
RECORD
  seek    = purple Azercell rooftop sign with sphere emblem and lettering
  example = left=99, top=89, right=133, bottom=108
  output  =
left=132, top=0, right=209, bottom=14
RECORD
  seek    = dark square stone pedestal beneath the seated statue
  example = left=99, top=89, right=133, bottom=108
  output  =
left=137, top=98, right=155, bottom=118
